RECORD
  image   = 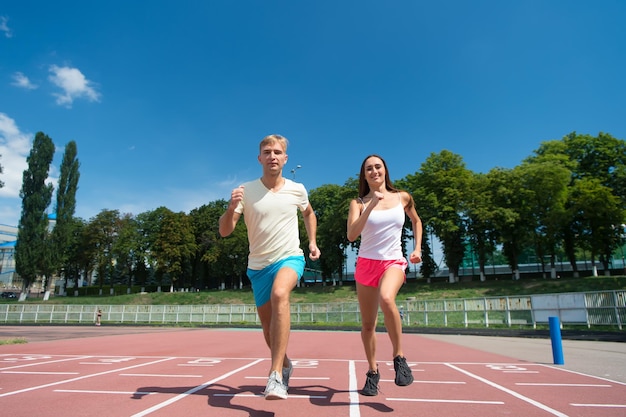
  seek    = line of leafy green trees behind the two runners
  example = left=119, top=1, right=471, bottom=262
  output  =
left=9, top=132, right=626, bottom=294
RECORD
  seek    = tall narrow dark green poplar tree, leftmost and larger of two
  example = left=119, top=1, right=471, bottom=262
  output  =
left=15, top=132, right=54, bottom=301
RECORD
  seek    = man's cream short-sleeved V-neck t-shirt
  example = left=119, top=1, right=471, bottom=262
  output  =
left=235, top=178, right=309, bottom=270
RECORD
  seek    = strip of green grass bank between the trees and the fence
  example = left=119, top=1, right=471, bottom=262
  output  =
left=2, top=276, right=626, bottom=305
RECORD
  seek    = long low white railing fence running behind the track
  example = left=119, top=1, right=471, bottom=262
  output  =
left=0, top=290, right=626, bottom=330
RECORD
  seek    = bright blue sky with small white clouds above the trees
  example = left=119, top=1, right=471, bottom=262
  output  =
left=0, top=0, right=626, bottom=225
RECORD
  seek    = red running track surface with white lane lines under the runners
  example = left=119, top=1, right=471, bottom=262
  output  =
left=0, top=327, right=626, bottom=417
